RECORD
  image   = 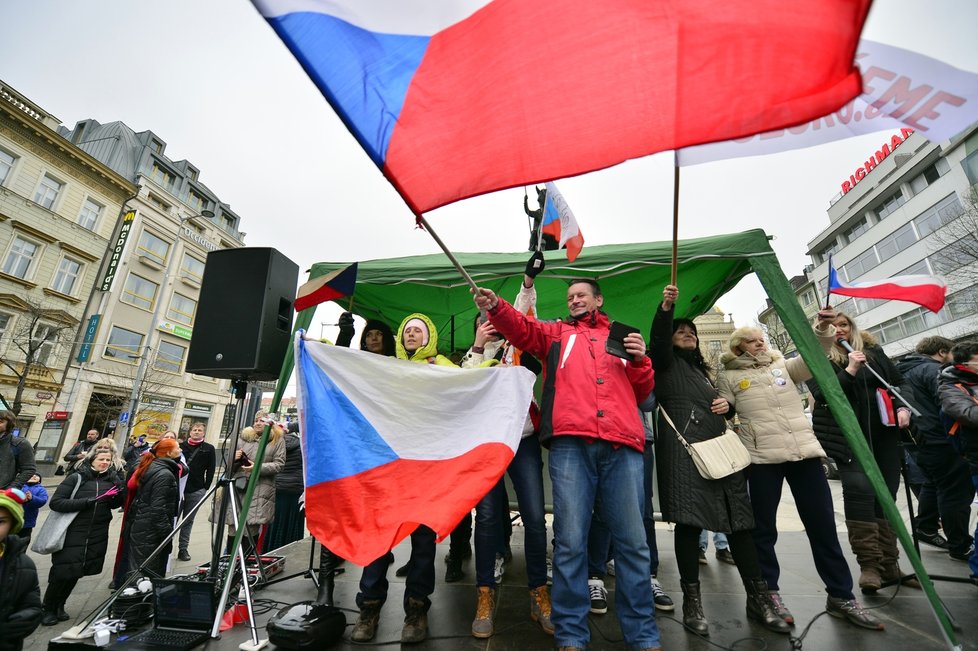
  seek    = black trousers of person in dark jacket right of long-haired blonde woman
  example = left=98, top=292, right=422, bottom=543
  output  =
left=917, top=444, right=975, bottom=552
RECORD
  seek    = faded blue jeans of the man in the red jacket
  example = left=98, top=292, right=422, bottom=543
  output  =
left=550, top=436, right=660, bottom=649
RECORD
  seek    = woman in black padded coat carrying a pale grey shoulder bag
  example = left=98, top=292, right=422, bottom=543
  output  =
left=41, top=447, right=126, bottom=626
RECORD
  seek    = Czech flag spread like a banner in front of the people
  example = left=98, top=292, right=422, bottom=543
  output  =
left=295, top=335, right=535, bottom=565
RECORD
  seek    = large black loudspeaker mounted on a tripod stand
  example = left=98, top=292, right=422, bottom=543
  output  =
left=187, top=248, right=299, bottom=380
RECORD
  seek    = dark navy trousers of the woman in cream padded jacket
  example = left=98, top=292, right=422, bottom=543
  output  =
left=747, top=459, right=853, bottom=599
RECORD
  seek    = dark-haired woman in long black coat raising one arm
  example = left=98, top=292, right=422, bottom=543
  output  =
left=650, top=285, right=791, bottom=635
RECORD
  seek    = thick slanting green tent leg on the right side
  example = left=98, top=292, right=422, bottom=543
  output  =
left=750, top=254, right=961, bottom=651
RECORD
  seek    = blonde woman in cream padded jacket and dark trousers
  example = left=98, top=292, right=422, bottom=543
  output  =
left=717, top=316, right=883, bottom=630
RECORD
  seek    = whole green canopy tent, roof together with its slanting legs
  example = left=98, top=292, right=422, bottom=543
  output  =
left=235, top=229, right=961, bottom=649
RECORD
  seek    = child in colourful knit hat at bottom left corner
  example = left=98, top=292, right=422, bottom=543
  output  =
left=0, top=488, right=41, bottom=651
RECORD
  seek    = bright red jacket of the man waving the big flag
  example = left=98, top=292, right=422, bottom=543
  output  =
left=489, top=299, right=655, bottom=452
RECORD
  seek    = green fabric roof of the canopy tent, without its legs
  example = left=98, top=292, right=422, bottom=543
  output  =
left=309, top=230, right=774, bottom=353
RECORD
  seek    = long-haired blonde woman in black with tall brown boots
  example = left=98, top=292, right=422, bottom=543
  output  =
left=809, top=312, right=914, bottom=592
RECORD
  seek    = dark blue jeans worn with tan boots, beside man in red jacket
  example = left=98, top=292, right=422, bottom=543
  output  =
left=475, top=436, right=547, bottom=588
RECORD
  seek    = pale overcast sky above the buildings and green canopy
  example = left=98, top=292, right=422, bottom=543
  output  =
left=0, top=0, right=978, bottom=336
